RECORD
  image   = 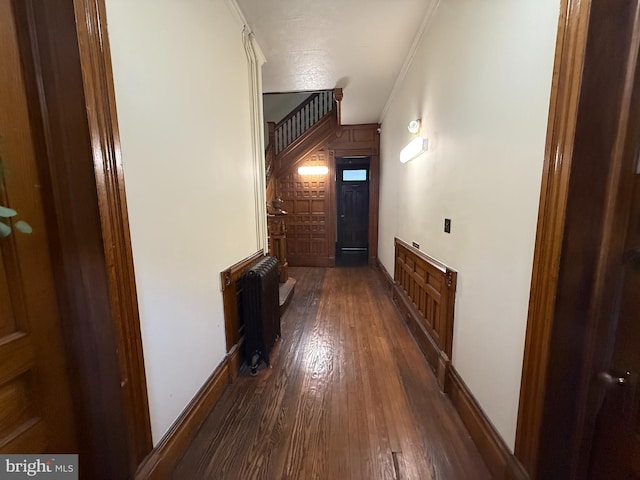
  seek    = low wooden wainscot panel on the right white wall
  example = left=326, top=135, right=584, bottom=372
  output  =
left=393, top=238, right=457, bottom=389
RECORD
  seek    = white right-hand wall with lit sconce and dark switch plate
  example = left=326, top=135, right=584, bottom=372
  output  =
left=380, top=0, right=559, bottom=448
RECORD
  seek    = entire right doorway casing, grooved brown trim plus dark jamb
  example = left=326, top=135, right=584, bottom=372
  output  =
left=515, top=0, right=638, bottom=479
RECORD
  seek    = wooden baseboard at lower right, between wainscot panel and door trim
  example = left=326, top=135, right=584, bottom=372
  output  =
left=445, top=366, right=529, bottom=480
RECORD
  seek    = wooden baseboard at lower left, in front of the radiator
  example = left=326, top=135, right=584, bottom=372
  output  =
left=135, top=356, right=230, bottom=480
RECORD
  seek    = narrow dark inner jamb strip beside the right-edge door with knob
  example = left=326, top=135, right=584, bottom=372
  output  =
left=571, top=4, right=640, bottom=478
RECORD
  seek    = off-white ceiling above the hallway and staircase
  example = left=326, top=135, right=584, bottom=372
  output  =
left=237, top=0, right=434, bottom=124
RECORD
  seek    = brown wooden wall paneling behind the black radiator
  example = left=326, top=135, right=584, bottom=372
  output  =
left=220, top=250, right=264, bottom=380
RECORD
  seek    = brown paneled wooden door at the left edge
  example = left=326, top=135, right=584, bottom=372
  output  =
left=0, top=0, right=77, bottom=453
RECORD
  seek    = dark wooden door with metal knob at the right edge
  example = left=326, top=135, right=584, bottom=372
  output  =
left=589, top=5, right=640, bottom=474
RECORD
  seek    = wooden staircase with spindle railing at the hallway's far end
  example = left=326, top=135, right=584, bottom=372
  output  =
left=265, top=88, right=342, bottom=192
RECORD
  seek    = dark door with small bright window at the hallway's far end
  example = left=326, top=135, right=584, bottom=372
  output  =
left=338, top=168, right=369, bottom=251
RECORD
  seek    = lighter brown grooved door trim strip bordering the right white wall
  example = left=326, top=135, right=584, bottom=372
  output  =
left=515, top=0, right=591, bottom=478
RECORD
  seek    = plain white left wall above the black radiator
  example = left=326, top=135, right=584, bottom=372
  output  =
left=106, top=0, right=258, bottom=444
